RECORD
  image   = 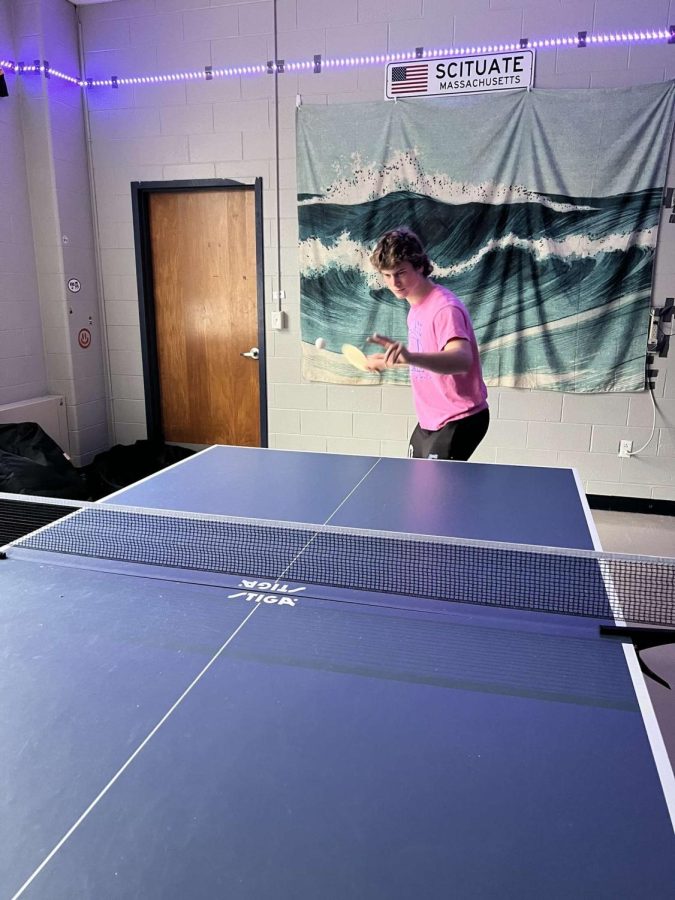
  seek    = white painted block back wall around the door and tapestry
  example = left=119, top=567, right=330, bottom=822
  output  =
left=3, top=0, right=675, bottom=500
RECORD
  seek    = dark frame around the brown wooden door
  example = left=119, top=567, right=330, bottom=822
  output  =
left=131, top=178, right=268, bottom=447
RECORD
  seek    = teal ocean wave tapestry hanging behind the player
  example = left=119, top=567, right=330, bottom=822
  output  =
left=297, top=81, right=675, bottom=392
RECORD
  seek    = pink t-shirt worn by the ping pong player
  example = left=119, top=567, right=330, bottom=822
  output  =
left=408, top=284, right=487, bottom=431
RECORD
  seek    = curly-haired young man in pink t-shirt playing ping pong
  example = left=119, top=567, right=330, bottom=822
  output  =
left=368, top=228, right=490, bottom=460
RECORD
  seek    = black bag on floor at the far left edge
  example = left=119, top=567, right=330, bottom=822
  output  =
left=0, top=422, right=89, bottom=500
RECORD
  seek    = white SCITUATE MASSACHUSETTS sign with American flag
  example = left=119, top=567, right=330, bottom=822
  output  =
left=385, top=48, right=534, bottom=100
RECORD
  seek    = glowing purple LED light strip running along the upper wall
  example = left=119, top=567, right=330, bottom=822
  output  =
left=0, top=26, right=675, bottom=88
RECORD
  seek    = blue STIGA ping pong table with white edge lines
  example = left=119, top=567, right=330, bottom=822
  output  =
left=0, top=446, right=675, bottom=900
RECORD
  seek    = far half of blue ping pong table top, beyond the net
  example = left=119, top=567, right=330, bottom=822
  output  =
left=109, top=447, right=593, bottom=550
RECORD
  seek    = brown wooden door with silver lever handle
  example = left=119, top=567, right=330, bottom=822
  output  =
left=147, top=185, right=264, bottom=446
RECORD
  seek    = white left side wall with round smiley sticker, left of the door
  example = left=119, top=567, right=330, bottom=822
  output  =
left=0, top=0, right=110, bottom=465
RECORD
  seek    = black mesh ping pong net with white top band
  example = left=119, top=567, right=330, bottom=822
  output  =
left=3, top=498, right=675, bottom=627
